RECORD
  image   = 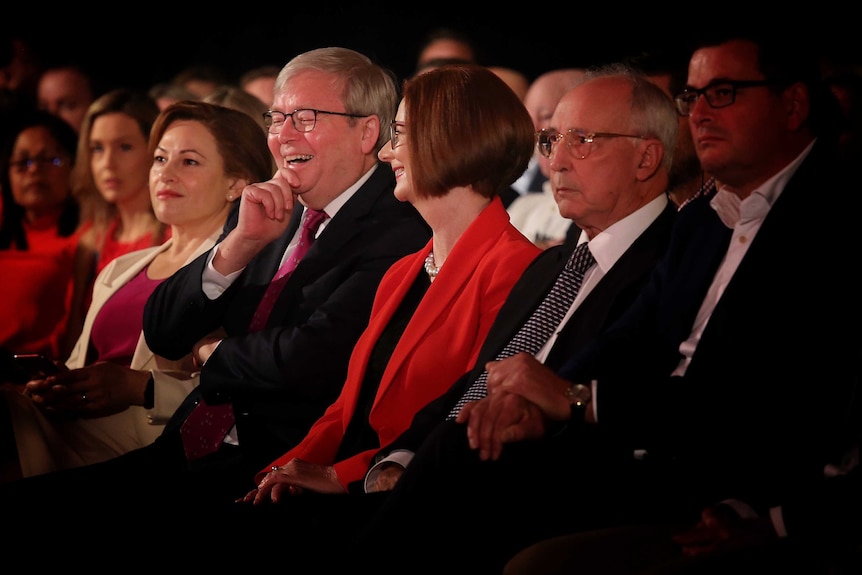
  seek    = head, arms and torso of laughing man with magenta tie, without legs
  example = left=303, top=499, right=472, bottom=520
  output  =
left=144, top=48, right=436, bottom=480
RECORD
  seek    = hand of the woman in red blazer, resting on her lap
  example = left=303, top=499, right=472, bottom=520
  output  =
left=236, top=459, right=345, bottom=505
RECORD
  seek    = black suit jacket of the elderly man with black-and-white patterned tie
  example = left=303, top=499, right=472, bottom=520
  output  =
left=368, top=198, right=676, bottom=472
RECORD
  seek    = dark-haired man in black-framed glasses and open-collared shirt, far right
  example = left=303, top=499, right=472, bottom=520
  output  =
left=394, top=30, right=862, bottom=575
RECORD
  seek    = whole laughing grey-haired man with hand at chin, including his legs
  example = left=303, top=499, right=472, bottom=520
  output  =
left=0, top=47, right=431, bottom=537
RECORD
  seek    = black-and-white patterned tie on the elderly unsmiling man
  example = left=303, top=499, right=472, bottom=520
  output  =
left=447, top=242, right=596, bottom=419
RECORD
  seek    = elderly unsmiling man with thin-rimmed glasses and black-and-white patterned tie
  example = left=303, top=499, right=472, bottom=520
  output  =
left=334, top=65, right=678, bottom=573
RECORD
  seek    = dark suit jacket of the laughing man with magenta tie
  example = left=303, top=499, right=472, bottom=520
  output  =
left=144, top=165, right=438, bottom=462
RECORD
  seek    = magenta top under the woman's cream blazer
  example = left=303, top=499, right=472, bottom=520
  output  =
left=90, top=268, right=164, bottom=367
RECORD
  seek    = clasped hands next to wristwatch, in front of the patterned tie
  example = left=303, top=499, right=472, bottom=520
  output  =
left=456, top=353, right=571, bottom=460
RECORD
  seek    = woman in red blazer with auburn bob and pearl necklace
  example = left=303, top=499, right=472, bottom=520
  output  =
left=243, top=65, right=539, bottom=503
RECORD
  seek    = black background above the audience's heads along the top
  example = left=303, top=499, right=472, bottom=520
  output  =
left=6, top=5, right=862, bottom=88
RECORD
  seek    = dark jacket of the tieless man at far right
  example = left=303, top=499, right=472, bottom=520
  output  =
left=559, top=143, right=862, bottom=511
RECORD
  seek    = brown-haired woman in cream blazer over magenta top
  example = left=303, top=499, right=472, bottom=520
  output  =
left=0, top=102, right=270, bottom=478
